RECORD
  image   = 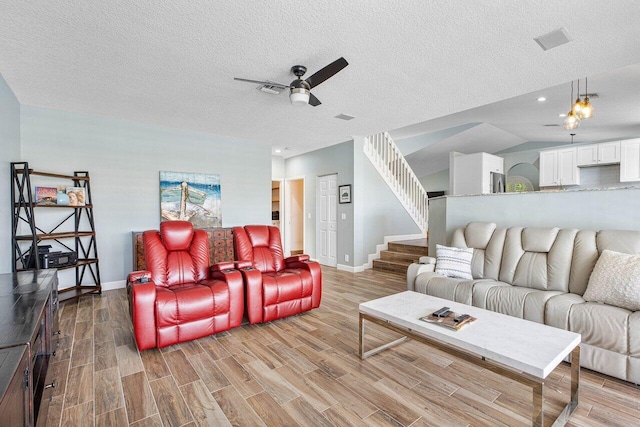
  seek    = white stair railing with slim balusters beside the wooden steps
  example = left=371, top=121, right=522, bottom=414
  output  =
left=364, top=132, right=429, bottom=233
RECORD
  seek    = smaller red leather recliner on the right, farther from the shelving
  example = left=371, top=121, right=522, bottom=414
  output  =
left=233, top=225, right=322, bottom=323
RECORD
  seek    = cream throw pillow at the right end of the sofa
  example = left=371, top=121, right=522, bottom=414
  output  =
left=583, top=249, right=640, bottom=311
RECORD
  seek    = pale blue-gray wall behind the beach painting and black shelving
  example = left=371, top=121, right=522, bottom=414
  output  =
left=18, top=105, right=272, bottom=285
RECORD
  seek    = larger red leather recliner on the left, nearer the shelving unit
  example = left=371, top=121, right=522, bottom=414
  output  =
left=127, top=221, right=244, bottom=350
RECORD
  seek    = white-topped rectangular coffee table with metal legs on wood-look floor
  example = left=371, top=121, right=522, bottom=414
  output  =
left=359, top=291, right=580, bottom=426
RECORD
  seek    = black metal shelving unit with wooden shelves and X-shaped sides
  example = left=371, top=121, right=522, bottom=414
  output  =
left=11, top=162, right=102, bottom=301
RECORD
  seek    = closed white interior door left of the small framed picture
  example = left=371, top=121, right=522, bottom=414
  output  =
left=316, top=174, right=338, bottom=267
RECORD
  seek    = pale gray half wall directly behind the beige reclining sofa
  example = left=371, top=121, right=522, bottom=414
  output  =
left=429, top=188, right=640, bottom=253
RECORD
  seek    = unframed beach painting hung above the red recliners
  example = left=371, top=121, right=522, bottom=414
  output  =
left=160, top=171, right=222, bottom=228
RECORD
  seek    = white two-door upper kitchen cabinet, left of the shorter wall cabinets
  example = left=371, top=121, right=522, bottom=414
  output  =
left=540, top=147, right=580, bottom=187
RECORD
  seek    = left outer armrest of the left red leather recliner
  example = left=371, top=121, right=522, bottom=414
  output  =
left=127, top=275, right=157, bottom=351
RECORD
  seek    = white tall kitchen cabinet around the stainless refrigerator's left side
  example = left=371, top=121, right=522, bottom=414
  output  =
left=452, top=153, right=504, bottom=195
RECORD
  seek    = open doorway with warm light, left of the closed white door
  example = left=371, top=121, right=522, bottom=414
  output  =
left=284, top=178, right=304, bottom=256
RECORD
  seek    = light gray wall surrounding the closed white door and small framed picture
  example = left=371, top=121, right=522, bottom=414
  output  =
left=285, top=141, right=358, bottom=265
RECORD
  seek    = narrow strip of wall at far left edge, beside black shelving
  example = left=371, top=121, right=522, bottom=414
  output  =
left=0, top=75, right=20, bottom=273
